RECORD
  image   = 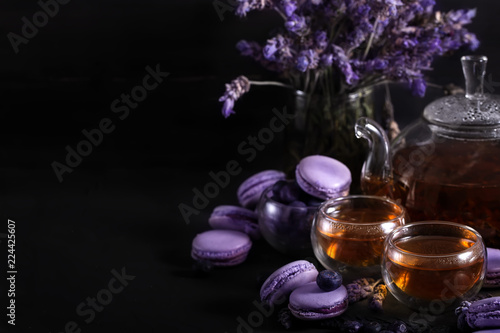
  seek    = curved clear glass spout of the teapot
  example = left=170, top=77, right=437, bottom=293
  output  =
left=355, top=117, right=394, bottom=198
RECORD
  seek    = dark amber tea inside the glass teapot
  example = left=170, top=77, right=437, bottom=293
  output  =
left=361, top=139, right=500, bottom=247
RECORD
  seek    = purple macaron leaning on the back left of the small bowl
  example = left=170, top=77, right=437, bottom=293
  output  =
left=236, top=170, right=286, bottom=209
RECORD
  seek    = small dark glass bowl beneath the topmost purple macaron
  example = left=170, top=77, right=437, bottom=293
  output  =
left=257, top=186, right=318, bottom=255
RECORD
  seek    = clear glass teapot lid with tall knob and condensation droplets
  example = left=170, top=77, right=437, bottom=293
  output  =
left=424, top=56, right=500, bottom=139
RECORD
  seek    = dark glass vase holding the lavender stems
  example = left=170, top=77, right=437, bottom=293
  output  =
left=284, top=87, right=375, bottom=193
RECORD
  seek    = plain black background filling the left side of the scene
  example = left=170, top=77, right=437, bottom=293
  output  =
left=0, top=0, right=500, bottom=332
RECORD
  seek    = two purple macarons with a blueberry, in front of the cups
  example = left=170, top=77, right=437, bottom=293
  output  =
left=260, top=260, right=348, bottom=320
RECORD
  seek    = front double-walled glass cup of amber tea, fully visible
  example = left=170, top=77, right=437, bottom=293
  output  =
left=382, top=221, right=486, bottom=308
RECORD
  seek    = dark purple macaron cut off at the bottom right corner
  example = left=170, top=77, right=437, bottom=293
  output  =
left=455, top=296, right=500, bottom=329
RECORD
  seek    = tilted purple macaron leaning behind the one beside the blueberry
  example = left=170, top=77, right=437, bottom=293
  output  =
left=260, top=260, right=318, bottom=305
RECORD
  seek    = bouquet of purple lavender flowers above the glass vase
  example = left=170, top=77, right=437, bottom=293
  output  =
left=219, top=0, right=479, bottom=117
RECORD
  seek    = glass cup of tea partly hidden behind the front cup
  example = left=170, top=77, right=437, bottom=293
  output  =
left=311, top=195, right=407, bottom=281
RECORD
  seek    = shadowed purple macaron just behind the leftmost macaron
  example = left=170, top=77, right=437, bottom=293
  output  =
left=208, top=205, right=260, bottom=239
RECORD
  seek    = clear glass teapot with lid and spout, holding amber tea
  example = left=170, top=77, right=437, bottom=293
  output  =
left=355, top=56, right=500, bottom=247
